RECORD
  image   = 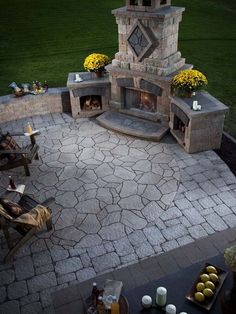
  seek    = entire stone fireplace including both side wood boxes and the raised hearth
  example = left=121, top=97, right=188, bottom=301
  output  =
left=67, top=0, right=228, bottom=153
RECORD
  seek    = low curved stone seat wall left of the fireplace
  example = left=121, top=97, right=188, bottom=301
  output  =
left=0, top=87, right=71, bottom=123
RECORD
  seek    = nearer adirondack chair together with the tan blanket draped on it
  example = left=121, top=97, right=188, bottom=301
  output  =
left=0, top=194, right=54, bottom=263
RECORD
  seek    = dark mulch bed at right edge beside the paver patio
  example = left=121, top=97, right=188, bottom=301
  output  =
left=215, top=134, right=236, bottom=176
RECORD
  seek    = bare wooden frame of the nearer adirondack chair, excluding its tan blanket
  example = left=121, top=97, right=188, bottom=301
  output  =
left=0, top=194, right=54, bottom=263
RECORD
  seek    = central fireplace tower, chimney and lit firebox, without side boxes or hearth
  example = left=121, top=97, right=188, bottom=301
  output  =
left=107, top=0, right=188, bottom=126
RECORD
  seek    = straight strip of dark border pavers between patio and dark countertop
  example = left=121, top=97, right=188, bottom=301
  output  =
left=52, top=228, right=236, bottom=314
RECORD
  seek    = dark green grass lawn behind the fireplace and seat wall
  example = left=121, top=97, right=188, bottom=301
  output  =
left=0, top=0, right=236, bottom=137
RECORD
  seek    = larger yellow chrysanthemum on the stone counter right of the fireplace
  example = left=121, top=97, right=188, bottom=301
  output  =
left=171, top=70, right=208, bottom=97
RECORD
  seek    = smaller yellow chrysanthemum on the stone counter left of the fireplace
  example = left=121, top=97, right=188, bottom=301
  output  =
left=84, top=53, right=110, bottom=76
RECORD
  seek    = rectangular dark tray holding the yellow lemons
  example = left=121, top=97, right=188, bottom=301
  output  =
left=186, top=263, right=228, bottom=311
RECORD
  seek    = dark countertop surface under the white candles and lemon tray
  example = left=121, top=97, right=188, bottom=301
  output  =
left=124, top=254, right=232, bottom=314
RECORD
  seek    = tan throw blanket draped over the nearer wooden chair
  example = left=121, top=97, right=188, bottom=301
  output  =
left=14, top=205, right=51, bottom=229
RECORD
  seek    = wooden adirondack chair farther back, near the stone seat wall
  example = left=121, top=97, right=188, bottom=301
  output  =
left=0, top=132, right=40, bottom=176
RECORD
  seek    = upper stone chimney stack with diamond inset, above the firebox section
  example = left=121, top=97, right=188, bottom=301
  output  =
left=112, top=0, right=185, bottom=76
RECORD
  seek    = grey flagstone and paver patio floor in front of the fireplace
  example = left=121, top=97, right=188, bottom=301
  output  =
left=0, top=114, right=236, bottom=313
